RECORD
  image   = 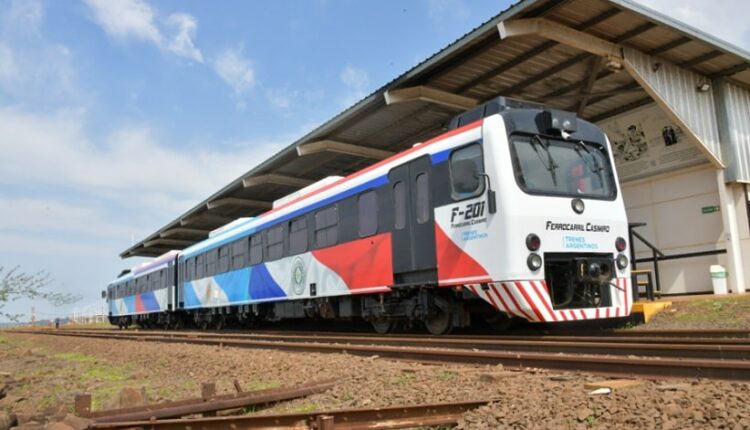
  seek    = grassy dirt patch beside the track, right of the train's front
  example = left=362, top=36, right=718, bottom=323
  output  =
left=634, top=294, right=750, bottom=330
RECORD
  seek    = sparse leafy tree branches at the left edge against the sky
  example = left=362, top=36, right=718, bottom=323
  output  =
left=0, top=266, right=81, bottom=321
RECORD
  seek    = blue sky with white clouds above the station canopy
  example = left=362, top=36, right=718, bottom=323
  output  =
left=0, top=0, right=750, bottom=321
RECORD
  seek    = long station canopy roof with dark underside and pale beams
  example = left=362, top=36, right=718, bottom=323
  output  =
left=120, top=0, right=750, bottom=258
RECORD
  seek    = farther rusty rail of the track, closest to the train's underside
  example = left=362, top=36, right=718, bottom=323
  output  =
left=25, top=331, right=750, bottom=360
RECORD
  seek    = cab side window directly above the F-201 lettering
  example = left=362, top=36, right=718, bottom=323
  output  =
left=450, top=143, right=485, bottom=200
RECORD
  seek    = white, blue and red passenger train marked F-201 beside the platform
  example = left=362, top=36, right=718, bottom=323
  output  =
left=102, top=97, right=632, bottom=335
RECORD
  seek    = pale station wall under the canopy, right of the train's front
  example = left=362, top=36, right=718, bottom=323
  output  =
left=622, top=165, right=736, bottom=294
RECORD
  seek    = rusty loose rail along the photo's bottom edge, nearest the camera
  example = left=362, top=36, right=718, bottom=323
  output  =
left=90, top=400, right=493, bottom=430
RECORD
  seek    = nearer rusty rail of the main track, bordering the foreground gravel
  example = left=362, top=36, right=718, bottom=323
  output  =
left=14, top=332, right=750, bottom=381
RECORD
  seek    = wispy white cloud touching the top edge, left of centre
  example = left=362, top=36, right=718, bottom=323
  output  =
left=83, top=0, right=203, bottom=63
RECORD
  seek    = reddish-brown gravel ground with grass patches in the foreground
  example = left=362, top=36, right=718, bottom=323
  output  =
left=0, top=333, right=750, bottom=429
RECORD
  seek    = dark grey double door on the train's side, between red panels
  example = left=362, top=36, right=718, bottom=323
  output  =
left=388, top=155, right=437, bottom=285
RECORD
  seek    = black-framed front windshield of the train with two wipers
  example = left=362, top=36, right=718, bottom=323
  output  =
left=511, top=135, right=616, bottom=200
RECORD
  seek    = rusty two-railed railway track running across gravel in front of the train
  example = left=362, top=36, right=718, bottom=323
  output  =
left=10, top=330, right=750, bottom=380
